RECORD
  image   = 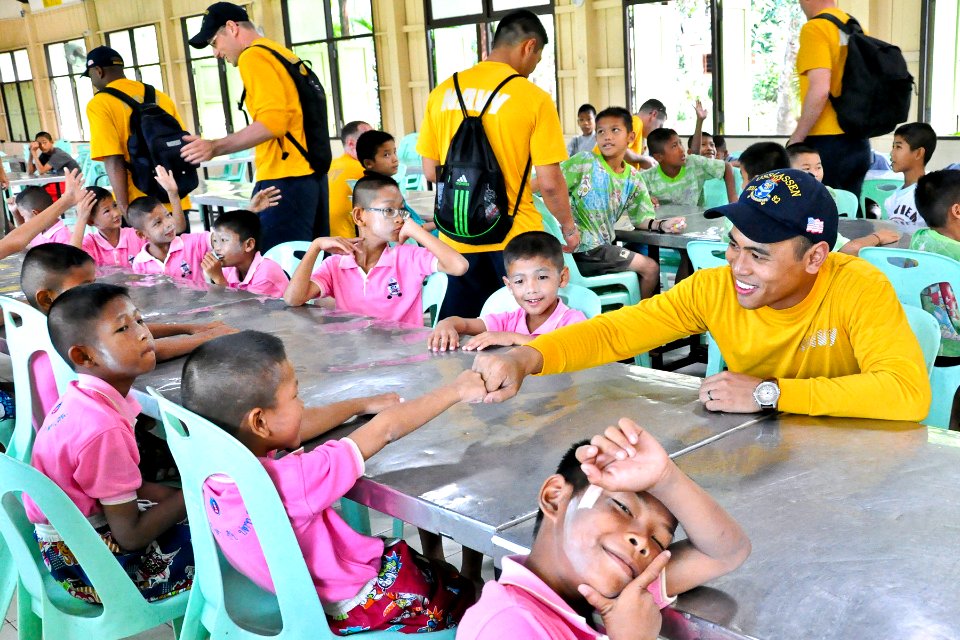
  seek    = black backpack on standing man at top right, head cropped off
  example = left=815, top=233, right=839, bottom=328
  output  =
left=816, top=13, right=913, bottom=138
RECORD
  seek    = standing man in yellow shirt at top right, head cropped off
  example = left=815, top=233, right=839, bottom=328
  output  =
left=787, top=0, right=871, bottom=196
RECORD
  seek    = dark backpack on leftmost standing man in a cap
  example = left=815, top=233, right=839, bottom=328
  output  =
left=101, top=84, right=200, bottom=202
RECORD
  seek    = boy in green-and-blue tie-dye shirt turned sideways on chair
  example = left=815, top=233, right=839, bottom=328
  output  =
left=560, top=107, right=686, bottom=298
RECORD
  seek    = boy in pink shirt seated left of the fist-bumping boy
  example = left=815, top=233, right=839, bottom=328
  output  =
left=23, top=284, right=194, bottom=602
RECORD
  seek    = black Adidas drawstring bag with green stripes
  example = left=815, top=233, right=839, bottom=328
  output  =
left=434, top=73, right=530, bottom=245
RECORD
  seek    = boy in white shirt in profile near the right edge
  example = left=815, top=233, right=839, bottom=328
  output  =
left=883, top=122, right=937, bottom=231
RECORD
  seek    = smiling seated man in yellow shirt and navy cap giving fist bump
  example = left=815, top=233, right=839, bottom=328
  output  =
left=474, top=169, right=930, bottom=420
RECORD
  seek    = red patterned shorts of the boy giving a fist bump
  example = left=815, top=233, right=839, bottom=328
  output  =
left=327, top=540, right=476, bottom=636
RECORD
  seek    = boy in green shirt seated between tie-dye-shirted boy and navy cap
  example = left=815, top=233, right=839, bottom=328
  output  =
left=640, top=128, right=737, bottom=206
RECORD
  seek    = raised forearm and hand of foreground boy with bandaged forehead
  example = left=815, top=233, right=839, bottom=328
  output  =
left=577, top=418, right=750, bottom=595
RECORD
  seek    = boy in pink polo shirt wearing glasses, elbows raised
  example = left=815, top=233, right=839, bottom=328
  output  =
left=283, top=174, right=468, bottom=326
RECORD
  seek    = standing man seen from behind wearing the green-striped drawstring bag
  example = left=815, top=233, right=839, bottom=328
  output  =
left=417, top=10, right=580, bottom=318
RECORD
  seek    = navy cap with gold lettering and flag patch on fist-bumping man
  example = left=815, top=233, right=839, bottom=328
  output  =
left=704, top=169, right=839, bottom=249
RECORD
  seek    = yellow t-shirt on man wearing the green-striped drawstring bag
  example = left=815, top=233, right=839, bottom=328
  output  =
left=417, top=60, right=567, bottom=253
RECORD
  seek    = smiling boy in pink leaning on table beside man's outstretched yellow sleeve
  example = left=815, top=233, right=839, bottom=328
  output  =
left=427, top=231, right=586, bottom=351
